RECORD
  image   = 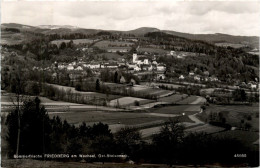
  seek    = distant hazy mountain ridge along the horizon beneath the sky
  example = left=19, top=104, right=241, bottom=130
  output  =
left=1, top=23, right=259, bottom=48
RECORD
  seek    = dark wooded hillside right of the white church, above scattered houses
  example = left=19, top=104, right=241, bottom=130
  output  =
left=145, top=32, right=259, bottom=82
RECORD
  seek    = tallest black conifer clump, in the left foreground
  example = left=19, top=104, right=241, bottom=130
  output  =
left=6, top=97, right=51, bottom=154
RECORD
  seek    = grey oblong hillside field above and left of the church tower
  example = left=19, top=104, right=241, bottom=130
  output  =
left=94, top=40, right=134, bottom=48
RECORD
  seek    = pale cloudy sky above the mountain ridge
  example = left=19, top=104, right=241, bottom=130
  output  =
left=1, top=0, right=260, bottom=36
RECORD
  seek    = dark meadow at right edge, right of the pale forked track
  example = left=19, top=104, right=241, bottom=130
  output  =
left=198, top=104, right=259, bottom=131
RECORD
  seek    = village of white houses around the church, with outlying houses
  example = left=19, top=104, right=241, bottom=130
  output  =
left=27, top=48, right=259, bottom=90
